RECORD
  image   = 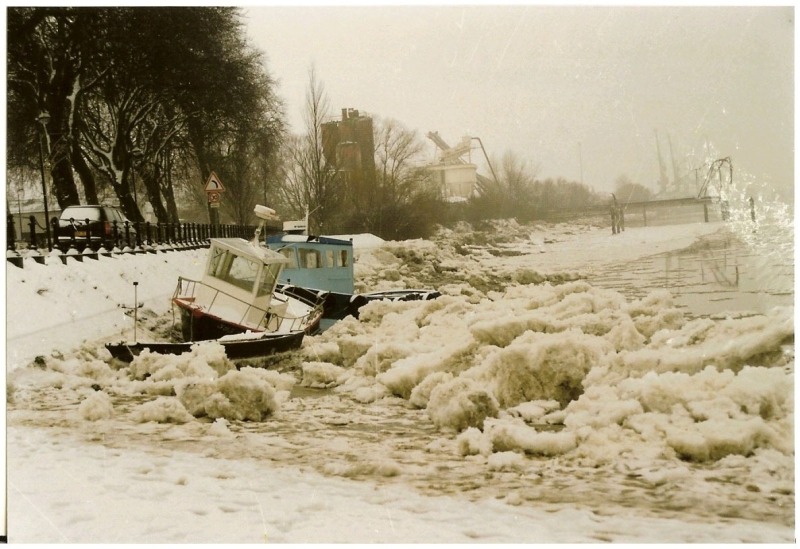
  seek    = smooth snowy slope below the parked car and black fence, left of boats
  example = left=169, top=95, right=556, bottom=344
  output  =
left=5, top=249, right=207, bottom=370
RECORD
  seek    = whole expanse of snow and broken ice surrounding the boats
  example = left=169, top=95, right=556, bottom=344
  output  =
left=6, top=212, right=795, bottom=543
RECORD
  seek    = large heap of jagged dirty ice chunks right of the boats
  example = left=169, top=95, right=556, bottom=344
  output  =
left=305, top=272, right=794, bottom=468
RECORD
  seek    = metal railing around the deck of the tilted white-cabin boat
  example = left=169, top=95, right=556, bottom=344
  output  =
left=172, top=276, right=323, bottom=331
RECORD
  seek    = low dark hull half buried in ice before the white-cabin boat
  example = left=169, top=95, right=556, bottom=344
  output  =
left=106, top=331, right=305, bottom=362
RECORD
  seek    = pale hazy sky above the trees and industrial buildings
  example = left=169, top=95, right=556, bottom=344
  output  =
left=245, top=4, right=794, bottom=198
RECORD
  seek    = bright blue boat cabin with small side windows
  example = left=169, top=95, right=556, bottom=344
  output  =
left=266, top=234, right=354, bottom=294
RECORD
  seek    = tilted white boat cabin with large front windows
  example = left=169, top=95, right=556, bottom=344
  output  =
left=193, top=238, right=288, bottom=329
